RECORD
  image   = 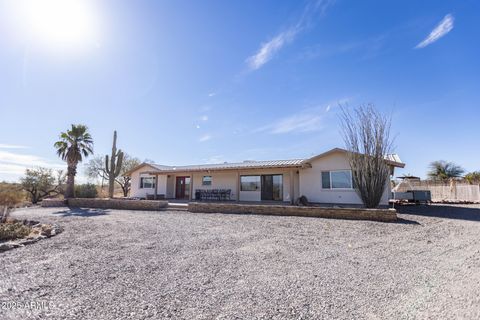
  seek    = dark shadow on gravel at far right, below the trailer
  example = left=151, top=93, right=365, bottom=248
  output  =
left=396, top=205, right=480, bottom=222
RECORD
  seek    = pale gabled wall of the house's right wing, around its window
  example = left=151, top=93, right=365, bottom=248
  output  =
left=299, top=152, right=390, bottom=205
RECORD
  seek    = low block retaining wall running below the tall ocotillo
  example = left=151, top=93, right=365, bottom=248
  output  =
left=188, top=202, right=397, bottom=222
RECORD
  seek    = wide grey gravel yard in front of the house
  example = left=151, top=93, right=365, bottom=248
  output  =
left=0, top=206, right=480, bottom=320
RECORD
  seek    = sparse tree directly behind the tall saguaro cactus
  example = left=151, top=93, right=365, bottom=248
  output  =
left=85, top=153, right=142, bottom=197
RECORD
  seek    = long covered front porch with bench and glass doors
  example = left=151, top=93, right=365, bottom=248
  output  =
left=140, top=168, right=299, bottom=203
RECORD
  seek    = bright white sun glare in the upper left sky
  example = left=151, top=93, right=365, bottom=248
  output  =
left=9, top=0, right=99, bottom=50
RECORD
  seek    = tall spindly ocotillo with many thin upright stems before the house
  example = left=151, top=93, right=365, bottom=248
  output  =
left=340, top=104, right=393, bottom=208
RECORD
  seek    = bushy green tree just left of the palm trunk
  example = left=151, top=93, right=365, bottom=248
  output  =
left=20, top=168, right=65, bottom=203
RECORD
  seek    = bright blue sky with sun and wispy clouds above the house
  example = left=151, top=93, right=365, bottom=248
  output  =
left=0, top=0, right=480, bottom=181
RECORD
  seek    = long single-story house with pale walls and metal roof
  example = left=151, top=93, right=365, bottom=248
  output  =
left=127, top=148, right=405, bottom=205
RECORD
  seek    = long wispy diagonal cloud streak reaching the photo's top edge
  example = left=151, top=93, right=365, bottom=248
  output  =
left=246, top=0, right=333, bottom=71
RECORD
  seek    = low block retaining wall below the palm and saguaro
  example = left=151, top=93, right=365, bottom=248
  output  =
left=41, top=198, right=168, bottom=210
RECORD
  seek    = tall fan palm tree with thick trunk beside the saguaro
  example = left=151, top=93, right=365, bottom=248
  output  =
left=54, top=124, right=93, bottom=198
